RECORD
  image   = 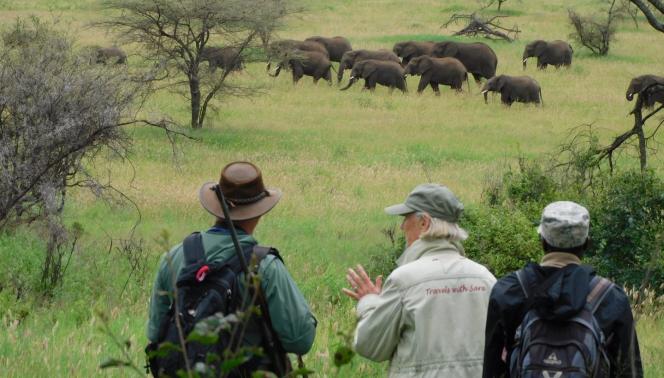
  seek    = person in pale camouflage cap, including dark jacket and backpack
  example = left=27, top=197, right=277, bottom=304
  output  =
left=483, top=201, right=643, bottom=378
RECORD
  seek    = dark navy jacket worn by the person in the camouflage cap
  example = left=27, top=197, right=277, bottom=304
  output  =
left=483, top=252, right=643, bottom=378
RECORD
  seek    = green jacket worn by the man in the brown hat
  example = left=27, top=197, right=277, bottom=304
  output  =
left=147, top=229, right=316, bottom=354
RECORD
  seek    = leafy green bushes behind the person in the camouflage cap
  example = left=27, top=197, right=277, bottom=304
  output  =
left=478, top=160, right=664, bottom=290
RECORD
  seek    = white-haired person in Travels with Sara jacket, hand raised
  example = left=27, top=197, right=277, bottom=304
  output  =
left=343, top=184, right=496, bottom=378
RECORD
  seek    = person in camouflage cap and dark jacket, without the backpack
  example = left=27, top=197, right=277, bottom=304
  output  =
left=482, top=201, right=643, bottom=378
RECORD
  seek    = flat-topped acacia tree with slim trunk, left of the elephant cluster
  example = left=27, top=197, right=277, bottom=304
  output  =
left=98, top=0, right=289, bottom=128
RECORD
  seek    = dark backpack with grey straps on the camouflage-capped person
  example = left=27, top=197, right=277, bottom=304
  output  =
left=510, top=269, right=613, bottom=378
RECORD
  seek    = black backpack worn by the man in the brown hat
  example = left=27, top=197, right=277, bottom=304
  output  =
left=146, top=232, right=287, bottom=377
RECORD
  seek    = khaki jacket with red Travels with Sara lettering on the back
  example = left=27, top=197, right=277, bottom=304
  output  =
left=355, top=239, right=496, bottom=378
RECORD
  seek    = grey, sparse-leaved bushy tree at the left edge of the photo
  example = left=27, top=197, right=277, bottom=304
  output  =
left=0, top=18, right=163, bottom=293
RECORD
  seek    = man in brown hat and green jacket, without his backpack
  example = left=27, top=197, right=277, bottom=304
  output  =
left=147, top=162, right=316, bottom=374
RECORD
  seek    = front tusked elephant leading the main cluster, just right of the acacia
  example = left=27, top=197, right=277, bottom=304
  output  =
left=271, top=50, right=332, bottom=84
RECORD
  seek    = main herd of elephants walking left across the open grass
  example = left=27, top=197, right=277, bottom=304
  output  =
left=267, top=36, right=573, bottom=105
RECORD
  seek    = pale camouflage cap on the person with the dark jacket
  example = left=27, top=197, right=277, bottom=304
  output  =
left=537, top=201, right=590, bottom=248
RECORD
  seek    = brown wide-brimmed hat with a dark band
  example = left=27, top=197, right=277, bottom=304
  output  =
left=198, top=161, right=282, bottom=221
